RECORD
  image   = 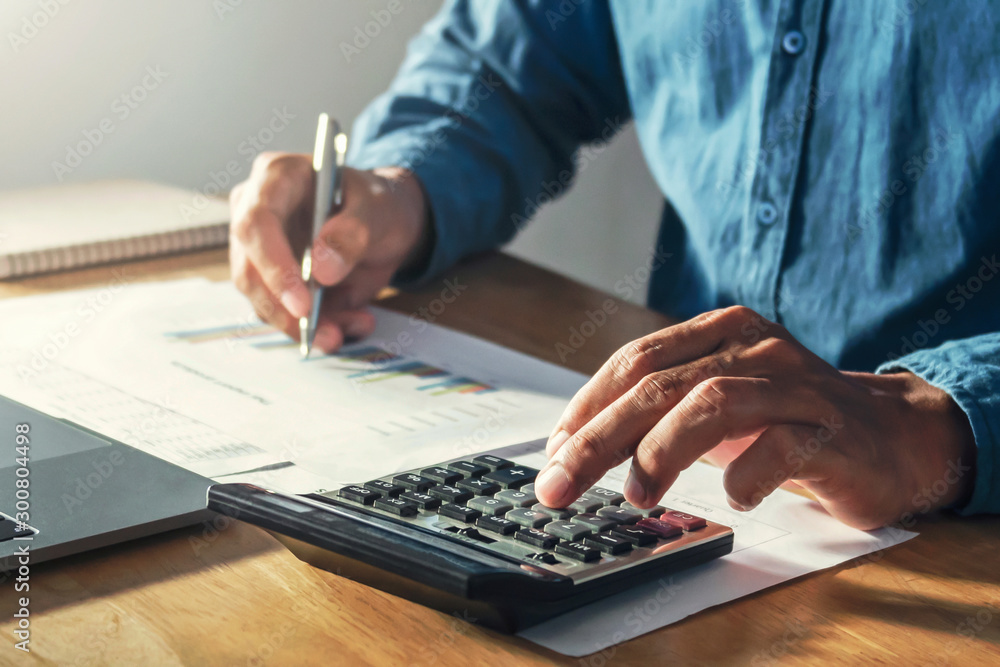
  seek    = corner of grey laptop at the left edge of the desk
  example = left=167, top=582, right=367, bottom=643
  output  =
left=0, top=396, right=213, bottom=572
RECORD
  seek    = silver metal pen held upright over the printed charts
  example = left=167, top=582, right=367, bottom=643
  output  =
left=299, top=113, right=347, bottom=359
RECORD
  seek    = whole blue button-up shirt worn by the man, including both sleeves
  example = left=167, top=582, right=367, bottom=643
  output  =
left=351, top=0, right=1000, bottom=513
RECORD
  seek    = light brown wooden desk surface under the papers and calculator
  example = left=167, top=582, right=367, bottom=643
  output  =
left=0, top=251, right=1000, bottom=667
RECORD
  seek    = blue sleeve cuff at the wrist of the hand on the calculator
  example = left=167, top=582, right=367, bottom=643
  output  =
left=877, top=333, right=1000, bottom=514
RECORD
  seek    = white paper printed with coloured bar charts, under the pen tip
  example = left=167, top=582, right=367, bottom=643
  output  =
left=0, top=280, right=585, bottom=482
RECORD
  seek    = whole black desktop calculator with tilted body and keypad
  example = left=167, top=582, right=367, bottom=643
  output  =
left=208, top=453, right=733, bottom=632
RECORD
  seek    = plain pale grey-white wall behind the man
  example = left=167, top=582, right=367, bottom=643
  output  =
left=0, top=0, right=660, bottom=302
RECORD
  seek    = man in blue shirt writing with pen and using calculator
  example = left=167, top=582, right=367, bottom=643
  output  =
left=231, top=0, right=1000, bottom=528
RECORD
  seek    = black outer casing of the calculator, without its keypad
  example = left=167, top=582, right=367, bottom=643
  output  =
left=208, top=483, right=733, bottom=633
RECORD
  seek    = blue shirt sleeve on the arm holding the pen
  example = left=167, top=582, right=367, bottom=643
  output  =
left=348, top=0, right=629, bottom=285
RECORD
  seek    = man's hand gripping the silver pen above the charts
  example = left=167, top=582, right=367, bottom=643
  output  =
left=229, top=153, right=429, bottom=352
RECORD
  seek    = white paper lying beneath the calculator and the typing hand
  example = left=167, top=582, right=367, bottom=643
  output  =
left=490, top=445, right=917, bottom=657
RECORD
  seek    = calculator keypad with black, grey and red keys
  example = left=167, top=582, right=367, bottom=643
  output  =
left=325, top=454, right=731, bottom=580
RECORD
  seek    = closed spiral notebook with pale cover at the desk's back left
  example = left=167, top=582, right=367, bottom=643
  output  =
left=0, top=180, right=229, bottom=279
